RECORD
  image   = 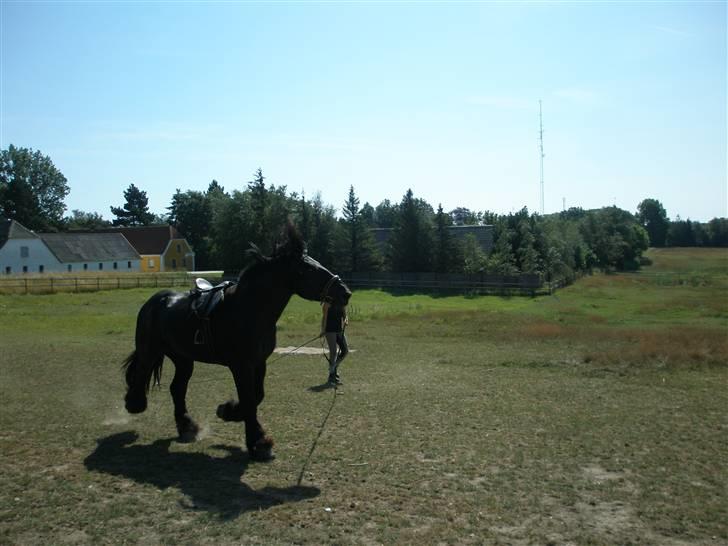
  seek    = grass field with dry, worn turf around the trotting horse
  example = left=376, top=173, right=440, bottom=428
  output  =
left=0, top=249, right=728, bottom=546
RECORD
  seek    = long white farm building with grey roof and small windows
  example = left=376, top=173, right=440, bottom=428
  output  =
left=0, top=219, right=141, bottom=275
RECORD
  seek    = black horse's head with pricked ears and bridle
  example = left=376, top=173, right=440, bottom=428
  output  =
left=276, top=224, right=351, bottom=305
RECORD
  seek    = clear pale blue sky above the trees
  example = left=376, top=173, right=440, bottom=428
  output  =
left=0, top=0, right=728, bottom=221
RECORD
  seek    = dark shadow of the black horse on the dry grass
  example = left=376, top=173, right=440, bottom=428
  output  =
left=84, top=431, right=321, bottom=519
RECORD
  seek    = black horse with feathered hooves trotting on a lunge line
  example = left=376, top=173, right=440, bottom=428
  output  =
left=124, top=224, right=351, bottom=460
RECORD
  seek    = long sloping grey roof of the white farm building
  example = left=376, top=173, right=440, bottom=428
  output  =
left=39, top=233, right=141, bottom=263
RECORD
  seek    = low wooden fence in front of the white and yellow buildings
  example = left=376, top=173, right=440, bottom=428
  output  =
left=0, top=274, right=192, bottom=294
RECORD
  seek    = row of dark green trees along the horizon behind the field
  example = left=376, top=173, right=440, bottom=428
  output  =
left=0, top=145, right=728, bottom=280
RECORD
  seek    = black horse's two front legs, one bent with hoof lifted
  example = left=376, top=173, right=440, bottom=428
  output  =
left=217, top=363, right=273, bottom=461
